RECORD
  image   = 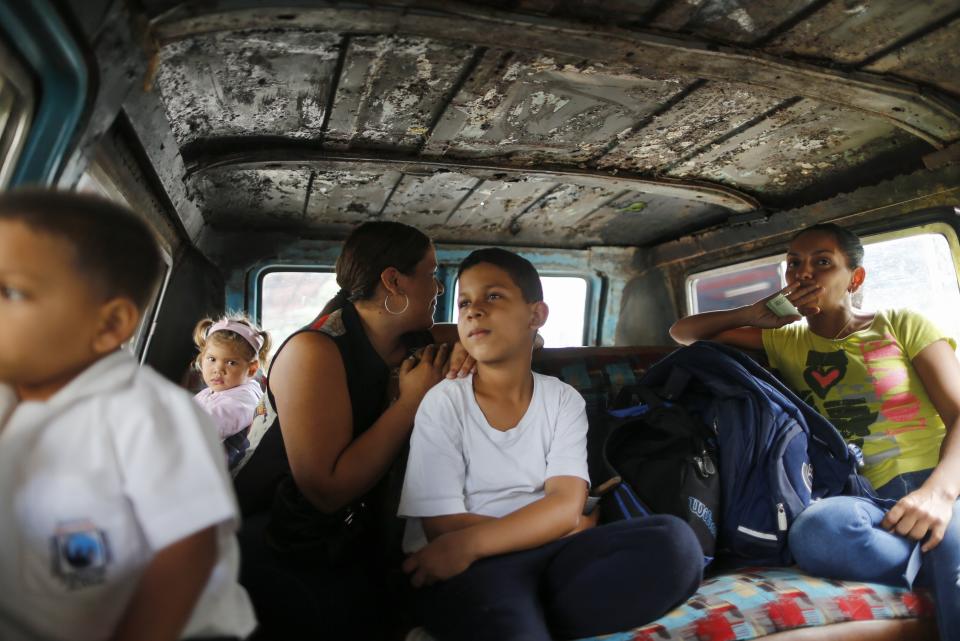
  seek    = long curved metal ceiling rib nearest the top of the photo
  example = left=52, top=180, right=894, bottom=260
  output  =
left=154, top=2, right=960, bottom=148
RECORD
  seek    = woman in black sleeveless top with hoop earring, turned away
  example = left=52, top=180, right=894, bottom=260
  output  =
left=235, top=222, right=472, bottom=640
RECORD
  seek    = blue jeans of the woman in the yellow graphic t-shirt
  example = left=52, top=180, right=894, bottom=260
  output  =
left=790, top=470, right=960, bottom=640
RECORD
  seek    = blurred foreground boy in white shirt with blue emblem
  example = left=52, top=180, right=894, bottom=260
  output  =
left=0, top=191, right=255, bottom=641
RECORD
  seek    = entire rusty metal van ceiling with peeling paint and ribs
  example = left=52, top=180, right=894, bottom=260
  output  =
left=141, top=0, right=960, bottom=247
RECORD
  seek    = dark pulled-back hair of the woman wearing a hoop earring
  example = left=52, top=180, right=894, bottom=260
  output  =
left=320, top=220, right=430, bottom=316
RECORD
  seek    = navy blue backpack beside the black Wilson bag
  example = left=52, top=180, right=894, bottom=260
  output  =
left=641, top=341, right=873, bottom=565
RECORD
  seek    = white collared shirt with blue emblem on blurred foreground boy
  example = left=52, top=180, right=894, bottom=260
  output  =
left=0, top=351, right=255, bottom=641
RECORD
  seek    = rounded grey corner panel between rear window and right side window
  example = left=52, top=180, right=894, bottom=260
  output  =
left=615, top=269, right=677, bottom=345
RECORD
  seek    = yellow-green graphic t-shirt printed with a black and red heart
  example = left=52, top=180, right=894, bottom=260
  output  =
left=763, top=310, right=956, bottom=488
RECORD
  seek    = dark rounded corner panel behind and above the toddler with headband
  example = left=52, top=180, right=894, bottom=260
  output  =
left=145, top=247, right=224, bottom=383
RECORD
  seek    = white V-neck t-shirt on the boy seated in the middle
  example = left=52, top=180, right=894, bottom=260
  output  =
left=399, top=372, right=590, bottom=553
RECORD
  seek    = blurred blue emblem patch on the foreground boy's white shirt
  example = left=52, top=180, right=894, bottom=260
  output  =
left=50, top=521, right=110, bottom=590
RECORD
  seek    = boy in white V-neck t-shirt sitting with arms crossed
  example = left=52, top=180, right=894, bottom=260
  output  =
left=399, top=248, right=702, bottom=641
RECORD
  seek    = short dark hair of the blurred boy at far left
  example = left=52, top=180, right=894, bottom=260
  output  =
left=0, top=189, right=163, bottom=312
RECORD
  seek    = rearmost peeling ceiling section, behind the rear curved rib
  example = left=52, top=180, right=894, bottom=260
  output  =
left=187, top=164, right=729, bottom=248
